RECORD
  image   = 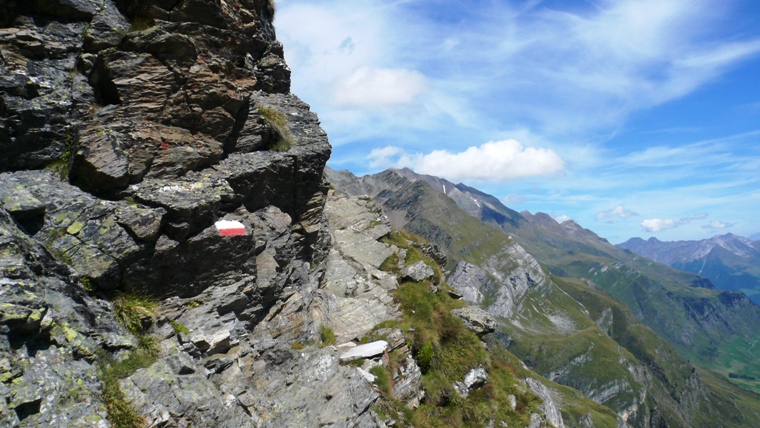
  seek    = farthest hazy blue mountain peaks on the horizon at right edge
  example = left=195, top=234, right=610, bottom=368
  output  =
left=617, top=233, right=760, bottom=304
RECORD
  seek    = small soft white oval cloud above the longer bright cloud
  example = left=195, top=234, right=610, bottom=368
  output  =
left=332, top=66, right=429, bottom=109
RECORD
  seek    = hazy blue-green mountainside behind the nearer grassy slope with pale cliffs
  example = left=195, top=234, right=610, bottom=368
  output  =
left=342, top=166, right=760, bottom=391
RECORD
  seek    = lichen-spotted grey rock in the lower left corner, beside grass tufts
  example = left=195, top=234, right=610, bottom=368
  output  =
left=0, top=209, right=136, bottom=427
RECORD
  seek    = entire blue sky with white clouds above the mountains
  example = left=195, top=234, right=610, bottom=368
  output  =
left=275, top=0, right=760, bottom=243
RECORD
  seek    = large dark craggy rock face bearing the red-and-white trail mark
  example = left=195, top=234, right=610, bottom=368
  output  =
left=0, top=0, right=395, bottom=427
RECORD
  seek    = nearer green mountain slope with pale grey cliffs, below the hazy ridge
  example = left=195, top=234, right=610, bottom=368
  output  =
left=328, top=166, right=760, bottom=426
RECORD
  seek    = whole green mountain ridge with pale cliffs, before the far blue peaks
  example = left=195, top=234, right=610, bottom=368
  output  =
left=325, top=169, right=760, bottom=427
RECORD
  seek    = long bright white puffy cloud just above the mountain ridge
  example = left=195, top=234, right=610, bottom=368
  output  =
left=368, top=140, right=565, bottom=182
